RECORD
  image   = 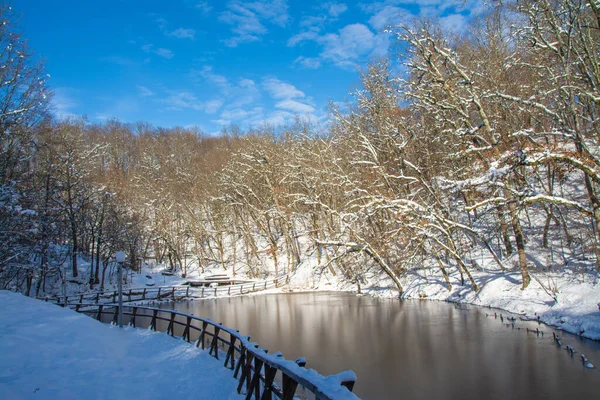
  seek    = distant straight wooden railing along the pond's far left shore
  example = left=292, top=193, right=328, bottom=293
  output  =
left=38, top=275, right=289, bottom=304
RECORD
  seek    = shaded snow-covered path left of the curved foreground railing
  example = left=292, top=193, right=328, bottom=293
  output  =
left=0, top=291, right=243, bottom=400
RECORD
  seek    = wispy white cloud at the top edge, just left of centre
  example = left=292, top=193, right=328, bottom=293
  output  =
left=219, top=0, right=289, bottom=47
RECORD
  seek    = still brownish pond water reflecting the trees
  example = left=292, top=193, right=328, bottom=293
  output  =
left=157, top=293, right=600, bottom=400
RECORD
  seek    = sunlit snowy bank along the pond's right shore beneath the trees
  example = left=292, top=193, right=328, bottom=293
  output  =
left=289, top=256, right=600, bottom=340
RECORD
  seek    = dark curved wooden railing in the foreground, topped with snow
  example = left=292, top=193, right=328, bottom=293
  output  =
left=66, top=303, right=358, bottom=400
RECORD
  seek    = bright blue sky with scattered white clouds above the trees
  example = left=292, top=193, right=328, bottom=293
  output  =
left=8, top=0, right=481, bottom=134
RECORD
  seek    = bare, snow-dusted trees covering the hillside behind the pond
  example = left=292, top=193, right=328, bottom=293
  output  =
left=0, top=0, right=600, bottom=292
